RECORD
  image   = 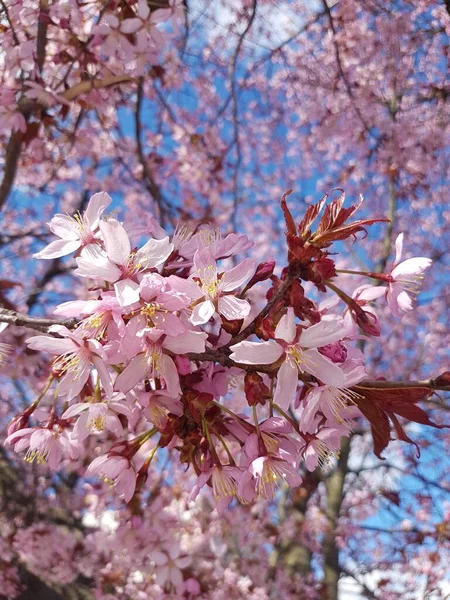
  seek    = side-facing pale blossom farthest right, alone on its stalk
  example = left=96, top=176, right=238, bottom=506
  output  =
left=386, top=233, right=432, bottom=317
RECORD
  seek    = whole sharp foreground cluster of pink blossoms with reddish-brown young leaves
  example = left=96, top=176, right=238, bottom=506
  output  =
left=1, top=192, right=435, bottom=506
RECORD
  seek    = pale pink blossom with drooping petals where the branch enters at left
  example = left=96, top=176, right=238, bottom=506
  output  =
left=27, top=325, right=112, bottom=401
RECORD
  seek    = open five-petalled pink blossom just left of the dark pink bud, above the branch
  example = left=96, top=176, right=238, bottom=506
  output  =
left=169, top=248, right=255, bottom=325
